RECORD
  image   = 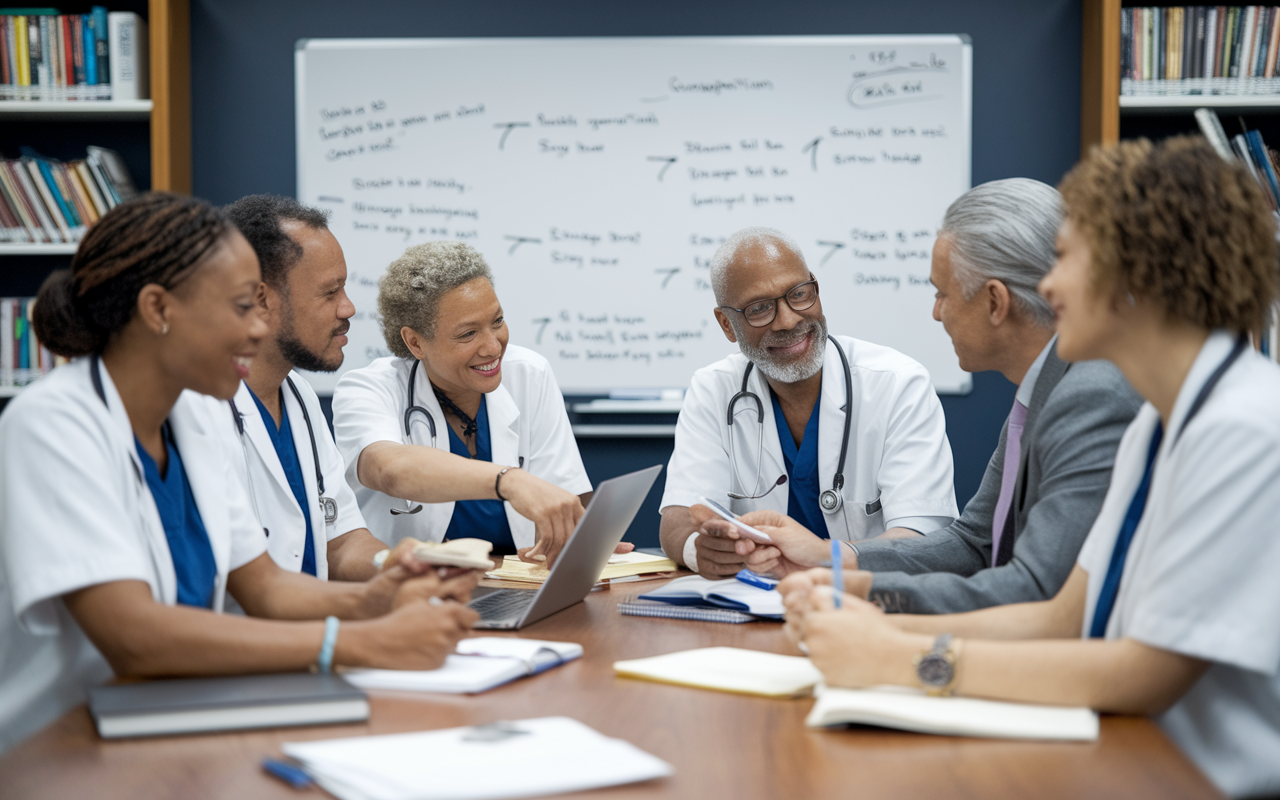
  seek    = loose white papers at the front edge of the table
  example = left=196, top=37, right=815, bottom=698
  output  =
left=283, top=717, right=673, bottom=800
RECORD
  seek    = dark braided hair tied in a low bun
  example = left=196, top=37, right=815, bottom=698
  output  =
left=32, top=192, right=234, bottom=358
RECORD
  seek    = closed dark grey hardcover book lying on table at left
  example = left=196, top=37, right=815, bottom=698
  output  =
left=88, top=672, right=369, bottom=739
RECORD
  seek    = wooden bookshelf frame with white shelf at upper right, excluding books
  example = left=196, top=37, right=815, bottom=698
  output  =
left=1080, top=0, right=1280, bottom=156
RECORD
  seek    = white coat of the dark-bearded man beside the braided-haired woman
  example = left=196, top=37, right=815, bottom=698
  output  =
left=232, top=372, right=365, bottom=580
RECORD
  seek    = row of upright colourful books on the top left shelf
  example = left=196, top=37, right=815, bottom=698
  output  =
left=0, top=5, right=148, bottom=101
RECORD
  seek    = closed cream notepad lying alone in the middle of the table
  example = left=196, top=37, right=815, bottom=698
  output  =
left=613, top=648, right=822, bottom=698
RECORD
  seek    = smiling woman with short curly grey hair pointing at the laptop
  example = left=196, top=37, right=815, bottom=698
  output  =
left=333, top=242, right=591, bottom=566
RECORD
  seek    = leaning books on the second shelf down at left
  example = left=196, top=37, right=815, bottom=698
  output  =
left=0, top=147, right=138, bottom=244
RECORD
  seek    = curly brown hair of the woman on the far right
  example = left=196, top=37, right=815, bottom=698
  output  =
left=1059, top=136, right=1280, bottom=333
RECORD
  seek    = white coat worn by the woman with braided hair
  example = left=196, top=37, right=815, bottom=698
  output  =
left=0, top=358, right=266, bottom=750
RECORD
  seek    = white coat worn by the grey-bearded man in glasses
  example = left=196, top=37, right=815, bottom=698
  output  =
left=662, top=337, right=957, bottom=541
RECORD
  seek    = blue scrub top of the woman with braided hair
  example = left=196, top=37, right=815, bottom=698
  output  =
left=133, top=422, right=218, bottom=608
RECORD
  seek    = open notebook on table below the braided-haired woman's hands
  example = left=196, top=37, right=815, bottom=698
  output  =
left=343, top=636, right=582, bottom=694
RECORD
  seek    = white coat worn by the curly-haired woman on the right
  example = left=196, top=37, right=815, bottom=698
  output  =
left=1079, top=330, right=1280, bottom=797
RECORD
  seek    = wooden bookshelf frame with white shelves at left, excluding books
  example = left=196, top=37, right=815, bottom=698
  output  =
left=0, top=0, right=191, bottom=399
